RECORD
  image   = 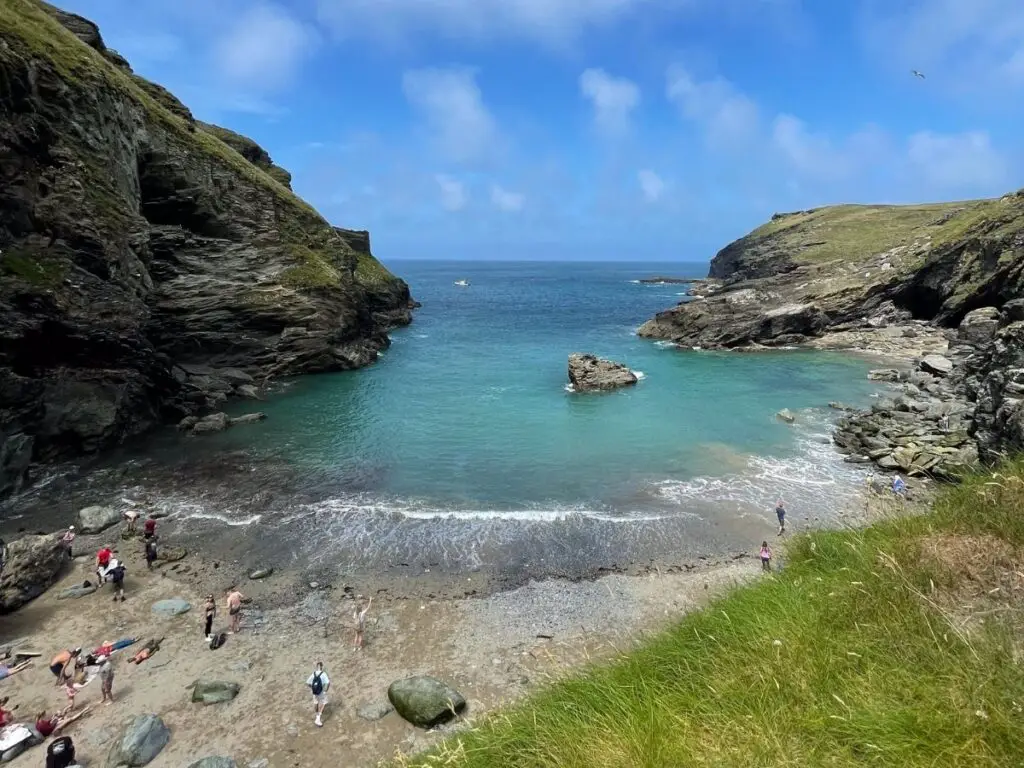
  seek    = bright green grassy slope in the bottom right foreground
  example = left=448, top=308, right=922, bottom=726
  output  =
left=398, top=462, right=1024, bottom=768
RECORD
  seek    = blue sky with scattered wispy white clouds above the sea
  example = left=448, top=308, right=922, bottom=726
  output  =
left=58, top=0, right=1024, bottom=261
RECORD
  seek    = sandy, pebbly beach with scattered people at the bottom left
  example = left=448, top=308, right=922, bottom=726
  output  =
left=0, top=538, right=760, bottom=768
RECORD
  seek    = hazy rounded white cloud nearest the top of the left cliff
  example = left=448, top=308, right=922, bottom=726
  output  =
left=213, top=4, right=317, bottom=90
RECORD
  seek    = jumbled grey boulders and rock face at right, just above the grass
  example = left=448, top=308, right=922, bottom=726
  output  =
left=834, top=300, right=1024, bottom=478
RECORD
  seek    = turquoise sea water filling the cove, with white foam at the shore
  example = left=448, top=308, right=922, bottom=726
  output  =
left=4, top=261, right=877, bottom=581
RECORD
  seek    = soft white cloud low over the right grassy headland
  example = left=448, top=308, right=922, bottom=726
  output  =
left=907, top=131, right=1009, bottom=190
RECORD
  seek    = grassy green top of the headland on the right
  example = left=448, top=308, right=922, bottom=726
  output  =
left=712, top=193, right=1024, bottom=278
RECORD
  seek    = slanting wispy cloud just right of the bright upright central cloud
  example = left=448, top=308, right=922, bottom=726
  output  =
left=666, top=66, right=760, bottom=148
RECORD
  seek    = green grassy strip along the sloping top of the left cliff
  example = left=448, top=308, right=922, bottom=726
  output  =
left=0, top=0, right=390, bottom=287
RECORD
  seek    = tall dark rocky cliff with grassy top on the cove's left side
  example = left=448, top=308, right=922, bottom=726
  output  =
left=0, top=0, right=412, bottom=497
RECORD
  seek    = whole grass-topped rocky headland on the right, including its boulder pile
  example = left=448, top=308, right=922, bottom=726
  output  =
left=638, top=190, right=1024, bottom=477
